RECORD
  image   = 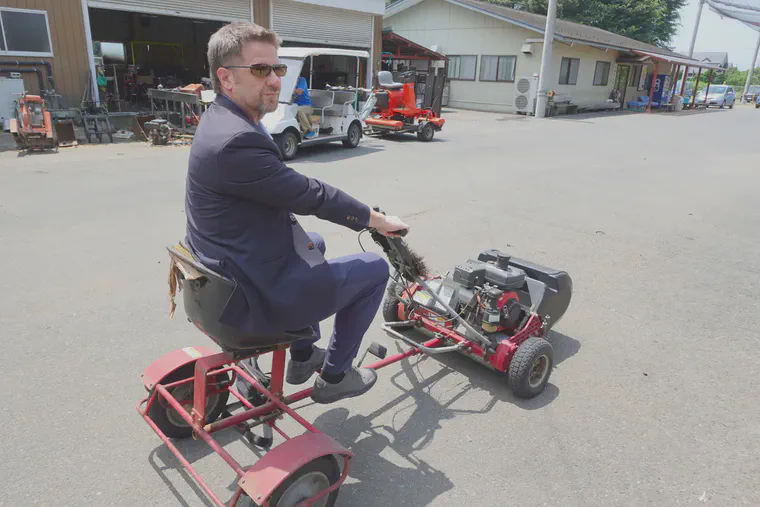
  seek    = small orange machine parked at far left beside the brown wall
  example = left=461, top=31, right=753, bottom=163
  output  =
left=10, top=93, right=58, bottom=151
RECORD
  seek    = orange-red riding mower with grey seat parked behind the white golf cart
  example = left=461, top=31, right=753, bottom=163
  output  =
left=364, top=70, right=446, bottom=142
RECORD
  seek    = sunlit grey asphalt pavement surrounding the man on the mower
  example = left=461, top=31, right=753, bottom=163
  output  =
left=0, top=107, right=760, bottom=507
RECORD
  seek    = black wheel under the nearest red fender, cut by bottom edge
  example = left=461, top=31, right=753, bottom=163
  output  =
left=269, top=455, right=340, bottom=507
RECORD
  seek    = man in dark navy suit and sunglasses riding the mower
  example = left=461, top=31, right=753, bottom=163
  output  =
left=185, top=23, right=408, bottom=403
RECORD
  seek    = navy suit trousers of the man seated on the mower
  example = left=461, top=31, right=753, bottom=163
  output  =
left=290, top=232, right=389, bottom=374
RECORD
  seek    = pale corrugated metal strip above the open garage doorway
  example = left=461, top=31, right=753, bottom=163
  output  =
left=87, top=0, right=251, bottom=21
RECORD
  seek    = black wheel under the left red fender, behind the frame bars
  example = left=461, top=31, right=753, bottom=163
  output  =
left=148, top=363, right=230, bottom=438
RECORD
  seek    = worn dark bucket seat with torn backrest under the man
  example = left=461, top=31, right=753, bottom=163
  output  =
left=167, top=244, right=316, bottom=357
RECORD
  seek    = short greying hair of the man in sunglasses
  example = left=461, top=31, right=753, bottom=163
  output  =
left=207, top=21, right=281, bottom=93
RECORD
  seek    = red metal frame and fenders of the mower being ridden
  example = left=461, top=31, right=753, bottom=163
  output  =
left=137, top=304, right=543, bottom=507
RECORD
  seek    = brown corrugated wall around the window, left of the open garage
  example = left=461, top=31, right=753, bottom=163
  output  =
left=0, top=0, right=90, bottom=107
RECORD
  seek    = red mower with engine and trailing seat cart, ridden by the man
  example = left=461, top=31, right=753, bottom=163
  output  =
left=137, top=212, right=572, bottom=507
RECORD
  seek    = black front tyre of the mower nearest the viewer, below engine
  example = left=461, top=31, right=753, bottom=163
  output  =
left=509, top=336, right=554, bottom=398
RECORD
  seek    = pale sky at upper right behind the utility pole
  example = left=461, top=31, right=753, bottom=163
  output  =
left=671, top=0, right=760, bottom=70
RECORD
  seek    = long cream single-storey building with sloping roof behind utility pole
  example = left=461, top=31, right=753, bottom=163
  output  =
left=383, top=0, right=720, bottom=112
